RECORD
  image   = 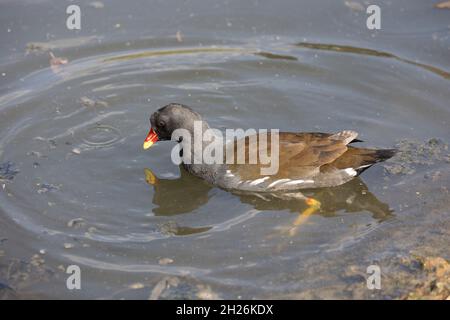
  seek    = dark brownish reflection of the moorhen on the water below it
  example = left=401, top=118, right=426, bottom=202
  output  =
left=144, top=168, right=393, bottom=233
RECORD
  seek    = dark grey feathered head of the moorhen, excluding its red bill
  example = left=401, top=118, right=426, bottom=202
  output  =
left=150, top=103, right=202, bottom=140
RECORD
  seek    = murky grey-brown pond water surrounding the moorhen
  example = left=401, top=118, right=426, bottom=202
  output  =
left=0, top=0, right=450, bottom=299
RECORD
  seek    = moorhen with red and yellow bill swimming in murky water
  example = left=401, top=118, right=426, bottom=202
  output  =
left=143, top=103, right=396, bottom=231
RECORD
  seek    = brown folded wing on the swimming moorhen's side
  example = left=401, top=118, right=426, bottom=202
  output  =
left=229, top=131, right=357, bottom=181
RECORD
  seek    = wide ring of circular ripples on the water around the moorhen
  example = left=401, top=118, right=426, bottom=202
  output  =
left=0, top=39, right=450, bottom=296
